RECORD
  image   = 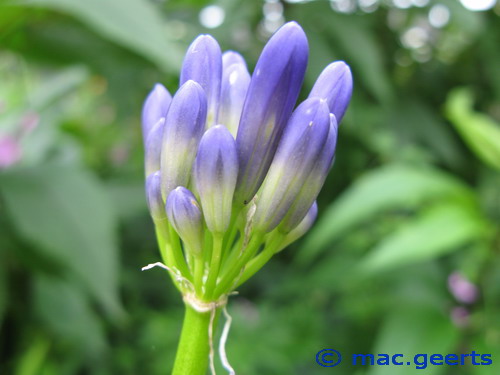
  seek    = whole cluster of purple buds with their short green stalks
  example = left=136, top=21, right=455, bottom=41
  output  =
left=142, top=22, right=352, bottom=301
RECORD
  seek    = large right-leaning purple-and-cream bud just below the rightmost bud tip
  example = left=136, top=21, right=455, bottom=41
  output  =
left=253, top=98, right=330, bottom=232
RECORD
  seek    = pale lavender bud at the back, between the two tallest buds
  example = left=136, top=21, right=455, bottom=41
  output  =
left=219, top=63, right=250, bottom=137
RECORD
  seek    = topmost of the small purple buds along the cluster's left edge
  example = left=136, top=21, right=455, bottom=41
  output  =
left=142, top=83, right=172, bottom=144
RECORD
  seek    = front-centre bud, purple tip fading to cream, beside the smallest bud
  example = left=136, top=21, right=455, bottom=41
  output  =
left=193, top=125, right=238, bottom=233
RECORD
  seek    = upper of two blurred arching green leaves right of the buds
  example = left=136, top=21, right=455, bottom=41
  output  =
left=298, top=165, right=472, bottom=262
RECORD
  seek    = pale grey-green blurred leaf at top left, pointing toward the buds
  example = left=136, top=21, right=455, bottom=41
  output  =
left=15, top=0, right=183, bottom=72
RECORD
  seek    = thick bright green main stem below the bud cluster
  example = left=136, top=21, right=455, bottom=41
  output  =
left=172, top=305, right=218, bottom=375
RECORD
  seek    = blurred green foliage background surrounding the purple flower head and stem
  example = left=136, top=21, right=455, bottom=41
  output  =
left=0, top=0, right=500, bottom=375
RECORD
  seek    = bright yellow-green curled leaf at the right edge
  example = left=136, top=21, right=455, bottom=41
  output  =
left=446, top=88, right=500, bottom=170
